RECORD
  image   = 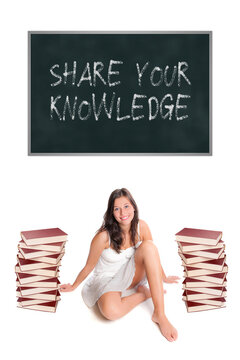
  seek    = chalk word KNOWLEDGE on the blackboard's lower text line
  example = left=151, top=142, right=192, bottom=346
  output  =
left=50, top=92, right=191, bottom=121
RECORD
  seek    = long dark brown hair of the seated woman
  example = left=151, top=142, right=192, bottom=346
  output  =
left=97, top=188, right=139, bottom=253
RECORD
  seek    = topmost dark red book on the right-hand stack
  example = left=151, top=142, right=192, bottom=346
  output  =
left=176, top=228, right=222, bottom=245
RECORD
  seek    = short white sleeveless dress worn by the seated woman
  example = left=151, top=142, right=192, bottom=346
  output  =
left=82, top=225, right=146, bottom=307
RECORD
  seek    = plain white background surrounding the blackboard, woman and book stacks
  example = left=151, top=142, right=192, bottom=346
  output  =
left=0, top=0, right=240, bottom=360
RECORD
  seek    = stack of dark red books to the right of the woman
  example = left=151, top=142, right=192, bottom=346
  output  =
left=176, top=228, right=228, bottom=312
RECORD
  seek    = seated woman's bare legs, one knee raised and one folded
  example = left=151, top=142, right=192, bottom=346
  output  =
left=98, top=240, right=177, bottom=341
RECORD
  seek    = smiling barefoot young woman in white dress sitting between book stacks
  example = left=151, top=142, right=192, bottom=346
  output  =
left=60, top=188, right=179, bottom=341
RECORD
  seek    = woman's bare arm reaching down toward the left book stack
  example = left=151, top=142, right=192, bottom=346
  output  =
left=59, top=231, right=108, bottom=292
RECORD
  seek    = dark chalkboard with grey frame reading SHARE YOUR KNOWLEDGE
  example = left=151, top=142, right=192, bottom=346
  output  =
left=29, top=32, right=212, bottom=155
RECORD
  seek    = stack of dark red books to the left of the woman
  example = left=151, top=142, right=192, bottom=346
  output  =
left=15, top=228, right=67, bottom=312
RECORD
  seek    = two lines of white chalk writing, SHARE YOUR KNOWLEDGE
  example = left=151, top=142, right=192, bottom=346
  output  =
left=49, top=59, right=192, bottom=122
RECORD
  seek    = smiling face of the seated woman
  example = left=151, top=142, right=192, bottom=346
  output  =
left=113, top=196, right=134, bottom=225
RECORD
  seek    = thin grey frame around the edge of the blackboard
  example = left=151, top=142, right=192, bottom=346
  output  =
left=28, top=31, right=212, bottom=156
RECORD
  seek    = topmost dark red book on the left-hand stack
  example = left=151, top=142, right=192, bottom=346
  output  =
left=21, top=228, right=67, bottom=245
